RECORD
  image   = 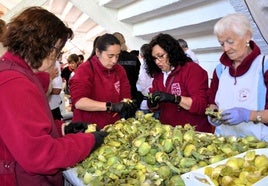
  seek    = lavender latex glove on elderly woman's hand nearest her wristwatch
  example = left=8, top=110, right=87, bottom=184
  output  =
left=221, top=107, right=250, bottom=125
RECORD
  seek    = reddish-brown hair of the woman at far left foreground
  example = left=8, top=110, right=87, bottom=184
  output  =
left=3, top=7, right=73, bottom=69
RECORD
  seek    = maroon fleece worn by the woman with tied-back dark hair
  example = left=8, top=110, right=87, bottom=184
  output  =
left=69, top=56, right=131, bottom=128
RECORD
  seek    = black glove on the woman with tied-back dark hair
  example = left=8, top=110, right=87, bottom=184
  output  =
left=111, top=100, right=137, bottom=119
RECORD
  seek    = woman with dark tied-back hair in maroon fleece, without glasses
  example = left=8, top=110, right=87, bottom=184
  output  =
left=69, top=34, right=137, bottom=129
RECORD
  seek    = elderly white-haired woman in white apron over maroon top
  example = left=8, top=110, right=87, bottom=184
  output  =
left=209, top=13, right=268, bottom=141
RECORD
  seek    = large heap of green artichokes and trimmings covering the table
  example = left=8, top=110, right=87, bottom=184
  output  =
left=76, top=112, right=268, bottom=186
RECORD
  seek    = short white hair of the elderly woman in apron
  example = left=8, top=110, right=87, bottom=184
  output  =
left=214, top=13, right=252, bottom=37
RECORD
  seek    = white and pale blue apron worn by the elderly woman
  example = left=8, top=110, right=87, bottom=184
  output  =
left=215, top=55, right=268, bottom=141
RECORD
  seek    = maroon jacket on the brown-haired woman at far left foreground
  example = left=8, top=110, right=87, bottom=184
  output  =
left=0, top=52, right=95, bottom=186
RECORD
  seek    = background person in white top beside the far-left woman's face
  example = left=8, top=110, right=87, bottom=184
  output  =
left=48, top=52, right=63, bottom=120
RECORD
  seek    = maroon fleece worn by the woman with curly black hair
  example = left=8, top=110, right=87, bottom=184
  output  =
left=150, top=62, right=211, bottom=132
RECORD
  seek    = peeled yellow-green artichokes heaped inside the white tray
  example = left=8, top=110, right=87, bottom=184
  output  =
left=204, top=151, right=268, bottom=186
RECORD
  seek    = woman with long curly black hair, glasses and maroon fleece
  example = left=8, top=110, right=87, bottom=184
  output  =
left=145, top=34, right=211, bottom=132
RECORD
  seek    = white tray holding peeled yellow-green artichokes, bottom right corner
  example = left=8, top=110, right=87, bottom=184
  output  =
left=182, top=148, right=268, bottom=186
